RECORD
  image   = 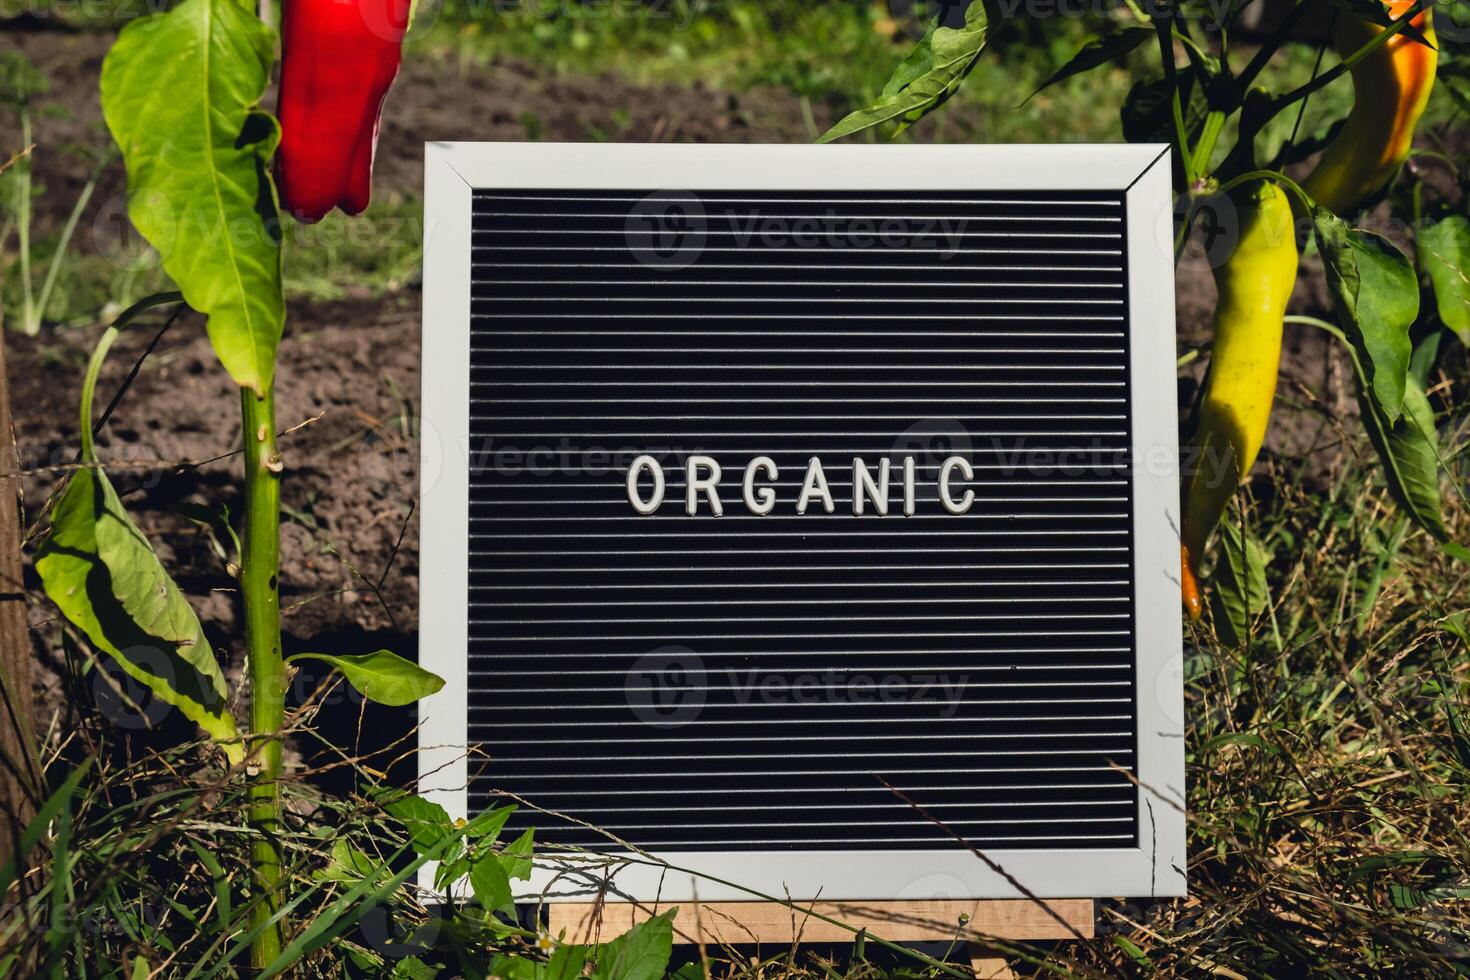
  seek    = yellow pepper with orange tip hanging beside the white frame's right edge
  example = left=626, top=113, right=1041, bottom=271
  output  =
left=1180, top=182, right=1297, bottom=619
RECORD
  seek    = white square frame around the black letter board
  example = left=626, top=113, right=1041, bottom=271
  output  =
left=419, top=143, right=1186, bottom=902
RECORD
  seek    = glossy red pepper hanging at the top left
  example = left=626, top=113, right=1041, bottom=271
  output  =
left=276, top=0, right=410, bottom=222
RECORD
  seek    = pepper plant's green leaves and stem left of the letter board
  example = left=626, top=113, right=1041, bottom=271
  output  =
left=37, top=0, right=442, bottom=970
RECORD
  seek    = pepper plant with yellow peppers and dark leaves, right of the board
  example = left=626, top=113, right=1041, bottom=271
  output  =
left=822, top=0, right=1470, bottom=642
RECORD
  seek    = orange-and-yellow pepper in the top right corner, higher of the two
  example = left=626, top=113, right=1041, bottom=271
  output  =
left=1302, top=0, right=1439, bottom=215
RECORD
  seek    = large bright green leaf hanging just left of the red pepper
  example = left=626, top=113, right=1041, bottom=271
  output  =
left=101, top=0, right=285, bottom=391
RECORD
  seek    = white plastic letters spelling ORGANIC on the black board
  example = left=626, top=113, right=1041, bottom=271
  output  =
left=628, top=455, right=993, bottom=517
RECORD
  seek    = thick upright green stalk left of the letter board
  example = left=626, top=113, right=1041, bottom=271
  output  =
left=240, top=388, right=285, bottom=970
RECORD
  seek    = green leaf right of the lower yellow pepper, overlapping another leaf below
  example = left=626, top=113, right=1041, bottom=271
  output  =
left=1311, top=207, right=1419, bottom=423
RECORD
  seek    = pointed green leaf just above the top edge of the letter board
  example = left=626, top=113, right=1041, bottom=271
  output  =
left=817, top=0, right=989, bottom=143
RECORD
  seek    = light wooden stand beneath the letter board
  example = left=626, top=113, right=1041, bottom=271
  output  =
left=547, top=898, right=1095, bottom=980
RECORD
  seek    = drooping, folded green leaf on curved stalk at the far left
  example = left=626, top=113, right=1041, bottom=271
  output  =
left=35, top=328, right=244, bottom=761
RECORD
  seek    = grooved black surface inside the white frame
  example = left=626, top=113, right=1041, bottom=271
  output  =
left=469, top=189, right=1138, bottom=851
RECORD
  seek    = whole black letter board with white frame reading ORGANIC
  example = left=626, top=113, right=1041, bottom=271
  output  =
left=420, top=144, right=1185, bottom=901
